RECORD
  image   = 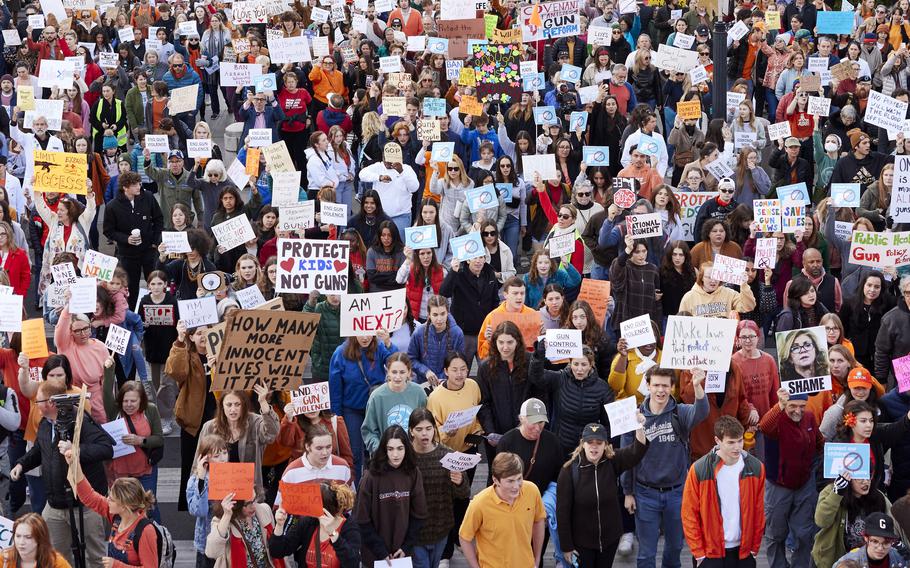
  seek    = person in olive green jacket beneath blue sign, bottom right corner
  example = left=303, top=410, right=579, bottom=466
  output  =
left=812, top=471, right=907, bottom=566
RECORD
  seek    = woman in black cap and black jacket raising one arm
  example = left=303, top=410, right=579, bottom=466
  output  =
left=556, top=420, right=648, bottom=568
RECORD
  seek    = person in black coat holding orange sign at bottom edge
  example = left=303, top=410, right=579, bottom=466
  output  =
left=269, top=481, right=360, bottom=568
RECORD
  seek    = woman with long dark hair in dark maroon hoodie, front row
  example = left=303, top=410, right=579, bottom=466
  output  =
left=354, top=424, right=427, bottom=566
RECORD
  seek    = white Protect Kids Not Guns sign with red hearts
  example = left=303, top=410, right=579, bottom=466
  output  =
left=275, top=239, right=350, bottom=294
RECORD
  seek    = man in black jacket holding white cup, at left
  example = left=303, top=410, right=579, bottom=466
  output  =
left=104, top=172, right=164, bottom=298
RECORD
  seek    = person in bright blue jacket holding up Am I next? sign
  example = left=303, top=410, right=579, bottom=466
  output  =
left=329, top=329, right=397, bottom=483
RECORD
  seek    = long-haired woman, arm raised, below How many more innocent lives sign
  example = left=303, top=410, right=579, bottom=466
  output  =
left=193, top=383, right=279, bottom=502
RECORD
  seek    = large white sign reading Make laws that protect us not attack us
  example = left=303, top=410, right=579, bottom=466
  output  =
left=660, top=316, right=736, bottom=372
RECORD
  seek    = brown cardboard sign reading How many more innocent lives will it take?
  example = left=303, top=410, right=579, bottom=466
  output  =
left=216, top=309, right=320, bottom=391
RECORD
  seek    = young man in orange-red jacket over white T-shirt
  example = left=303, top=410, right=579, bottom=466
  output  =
left=682, top=416, right=765, bottom=568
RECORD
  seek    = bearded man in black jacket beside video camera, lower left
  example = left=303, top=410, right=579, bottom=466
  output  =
left=10, top=380, right=114, bottom=567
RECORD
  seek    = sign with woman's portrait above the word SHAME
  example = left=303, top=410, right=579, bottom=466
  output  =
left=774, top=326, right=831, bottom=394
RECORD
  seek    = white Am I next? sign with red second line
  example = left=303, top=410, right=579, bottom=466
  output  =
left=340, top=288, right=407, bottom=337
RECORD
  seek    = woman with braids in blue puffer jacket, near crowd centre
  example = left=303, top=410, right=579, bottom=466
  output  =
left=408, top=296, right=464, bottom=387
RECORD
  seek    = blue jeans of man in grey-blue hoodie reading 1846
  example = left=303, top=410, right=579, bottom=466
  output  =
left=634, top=483, right=683, bottom=568
